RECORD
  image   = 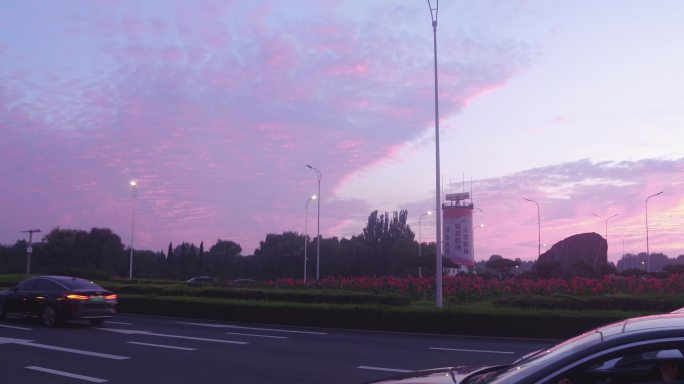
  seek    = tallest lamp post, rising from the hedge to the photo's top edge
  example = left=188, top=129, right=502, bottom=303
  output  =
left=428, top=0, right=443, bottom=308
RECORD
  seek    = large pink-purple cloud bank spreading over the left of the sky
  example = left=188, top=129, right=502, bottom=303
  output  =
left=0, top=2, right=526, bottom=253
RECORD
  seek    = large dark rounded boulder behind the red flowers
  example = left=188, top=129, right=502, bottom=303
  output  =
left=535, top=232, right=608, bottom=277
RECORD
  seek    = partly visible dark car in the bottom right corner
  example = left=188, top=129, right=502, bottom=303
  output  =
left=372, top=314, right=684, bottom=384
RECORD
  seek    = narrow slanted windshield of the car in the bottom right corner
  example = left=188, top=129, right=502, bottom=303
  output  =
left=463, top=330, right=604, bottom=384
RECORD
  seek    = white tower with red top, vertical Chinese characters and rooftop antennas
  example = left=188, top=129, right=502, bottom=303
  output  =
left=442, top=192, right=475, bottom=272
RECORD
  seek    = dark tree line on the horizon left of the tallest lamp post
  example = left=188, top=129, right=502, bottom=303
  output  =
left=0, top=210, right=449, bottom=280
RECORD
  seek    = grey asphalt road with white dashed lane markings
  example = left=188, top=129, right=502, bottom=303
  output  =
left=0, top=315, right=553, bottom=384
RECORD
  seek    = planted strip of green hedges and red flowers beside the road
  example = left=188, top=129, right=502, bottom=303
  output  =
left=0, top=274, right=684, bottom=338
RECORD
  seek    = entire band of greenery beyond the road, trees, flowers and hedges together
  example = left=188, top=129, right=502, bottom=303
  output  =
left=0, top=210, right=684, bottom=338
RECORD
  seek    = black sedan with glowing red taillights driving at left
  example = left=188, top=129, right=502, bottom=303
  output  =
left=0, top=276, right=117, bottom=326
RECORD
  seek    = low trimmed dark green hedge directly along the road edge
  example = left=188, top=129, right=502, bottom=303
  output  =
left=119, top=295, right=641, bottom=338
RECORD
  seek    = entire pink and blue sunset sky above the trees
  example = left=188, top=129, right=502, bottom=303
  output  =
left=0, top=0, right=684, bottom=261
